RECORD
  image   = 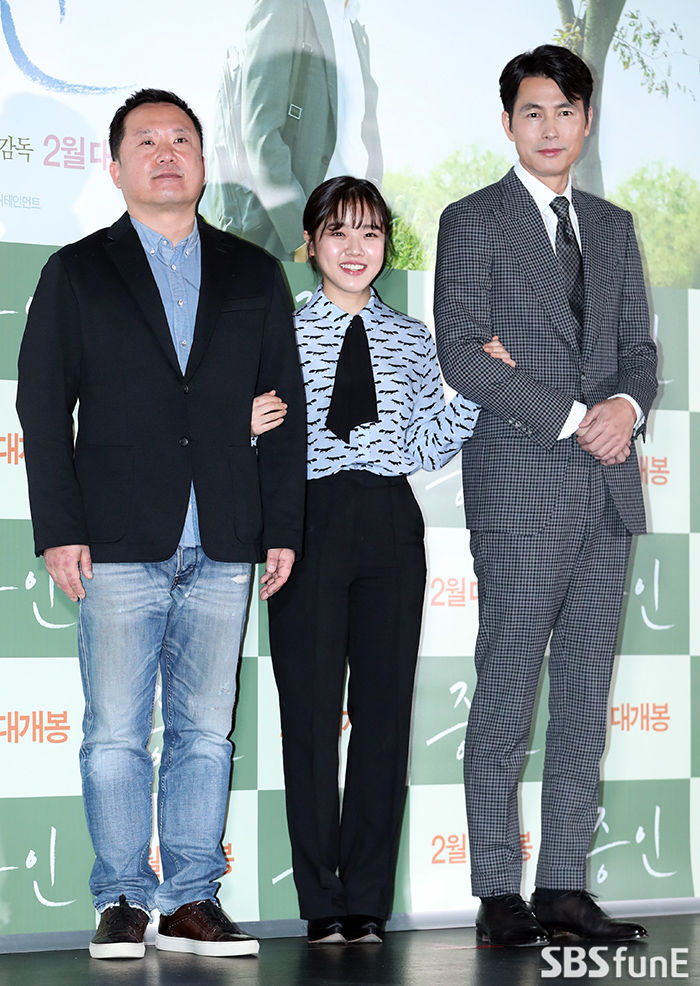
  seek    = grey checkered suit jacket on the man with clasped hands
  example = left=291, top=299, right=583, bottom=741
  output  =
left=435, top=170, right=656, bottom=534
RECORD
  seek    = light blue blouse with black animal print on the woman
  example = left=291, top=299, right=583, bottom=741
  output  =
left=294, top=286, right=479, bottom=479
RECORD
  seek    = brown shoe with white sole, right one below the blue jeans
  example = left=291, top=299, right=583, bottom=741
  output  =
left=156, top=900, right=260, bottom=956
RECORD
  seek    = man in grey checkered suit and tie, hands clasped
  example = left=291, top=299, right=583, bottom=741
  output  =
left=435, top=45, right=656, bottom=945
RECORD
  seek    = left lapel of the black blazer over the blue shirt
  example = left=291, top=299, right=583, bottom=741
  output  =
left=105, top=212, right=182, bottom=376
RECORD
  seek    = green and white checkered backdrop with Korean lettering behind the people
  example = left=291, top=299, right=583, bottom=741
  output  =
left=0, top=244, right=700, bottom=936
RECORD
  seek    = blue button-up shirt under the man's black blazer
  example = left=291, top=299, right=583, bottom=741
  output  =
left=130, top=216, right=202, bottom=547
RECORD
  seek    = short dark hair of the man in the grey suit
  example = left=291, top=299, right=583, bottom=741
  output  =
left=498, top=45, right=593, bottom=123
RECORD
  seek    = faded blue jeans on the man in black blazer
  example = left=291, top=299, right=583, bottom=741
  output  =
left=78, top=547, right=251, bottom=914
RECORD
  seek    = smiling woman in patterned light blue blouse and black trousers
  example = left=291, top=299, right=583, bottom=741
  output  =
left=263, top=176, right=510, bottom=943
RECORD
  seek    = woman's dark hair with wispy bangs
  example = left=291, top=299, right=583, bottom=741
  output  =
left=304, top=175, right=394, bottom=277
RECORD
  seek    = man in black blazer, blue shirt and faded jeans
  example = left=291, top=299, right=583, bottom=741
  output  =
left=17, top=90, right=306, bottom=958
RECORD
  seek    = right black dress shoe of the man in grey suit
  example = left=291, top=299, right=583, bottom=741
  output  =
left=532, top=890, right=647, bottom=941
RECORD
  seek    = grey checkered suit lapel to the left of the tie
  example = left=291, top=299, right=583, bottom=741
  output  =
left=501, top=171, right=585, bottom=350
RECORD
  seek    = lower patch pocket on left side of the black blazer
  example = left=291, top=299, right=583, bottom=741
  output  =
left=75, top=444, right=134, bottom=543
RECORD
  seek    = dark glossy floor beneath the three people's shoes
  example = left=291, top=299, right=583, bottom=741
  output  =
left=0, top=914, right=700, bottom=986
